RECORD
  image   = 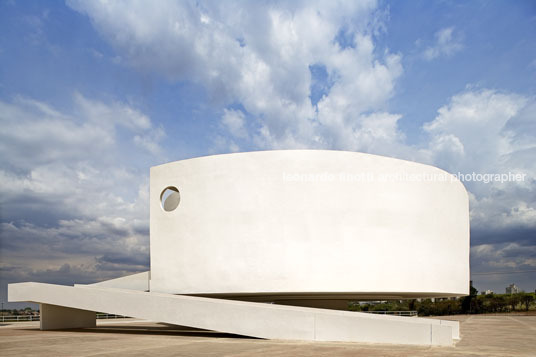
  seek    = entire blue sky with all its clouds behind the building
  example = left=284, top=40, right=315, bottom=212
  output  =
left=0, top=1, right=536, bottom=301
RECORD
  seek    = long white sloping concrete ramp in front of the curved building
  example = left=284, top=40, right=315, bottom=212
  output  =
left=8, top=283, right=459, bottom=346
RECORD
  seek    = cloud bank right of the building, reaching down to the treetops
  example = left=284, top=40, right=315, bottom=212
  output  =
left=421, top=89, right=536, bottom=292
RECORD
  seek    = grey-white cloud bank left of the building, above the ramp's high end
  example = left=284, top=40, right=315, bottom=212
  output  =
left=0, top=93, right=162, bottom=294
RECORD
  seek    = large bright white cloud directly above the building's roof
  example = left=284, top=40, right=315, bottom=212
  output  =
left=69, top=1, right=402, bottom=150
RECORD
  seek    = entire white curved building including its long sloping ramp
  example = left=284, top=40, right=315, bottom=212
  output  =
left=9, top=150, right=469, bottom=345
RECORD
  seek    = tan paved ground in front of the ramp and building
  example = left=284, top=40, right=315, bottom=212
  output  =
left=0, top=314, right=536, bottom=357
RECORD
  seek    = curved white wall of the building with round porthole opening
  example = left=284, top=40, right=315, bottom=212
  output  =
left=150, top=150, right=469, bottom=298
